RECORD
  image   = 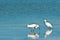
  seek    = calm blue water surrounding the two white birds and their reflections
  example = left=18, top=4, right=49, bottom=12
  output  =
left=0, top=0, right=60, bottom=40
